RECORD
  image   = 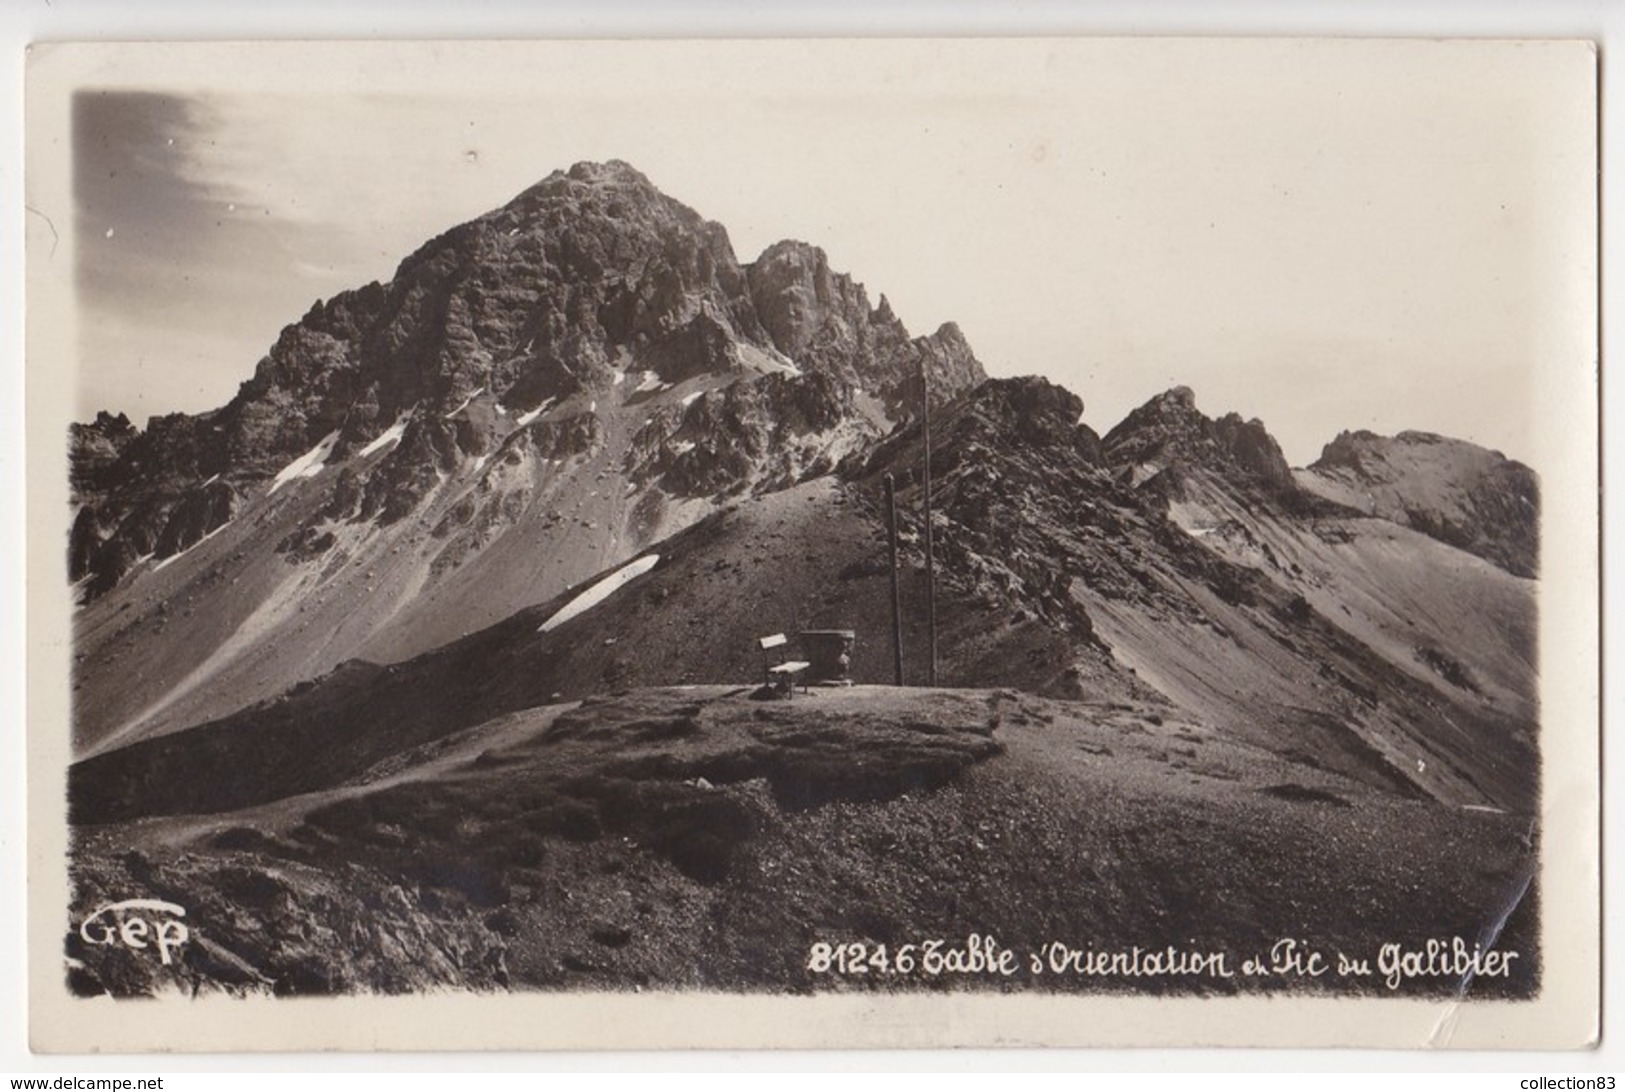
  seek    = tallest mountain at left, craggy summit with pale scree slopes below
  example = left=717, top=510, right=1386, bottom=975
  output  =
left=70, top=163, right=983, bottom=741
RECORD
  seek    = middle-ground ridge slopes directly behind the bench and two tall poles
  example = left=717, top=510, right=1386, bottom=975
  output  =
left=75, top=380, right=1536, bottom=821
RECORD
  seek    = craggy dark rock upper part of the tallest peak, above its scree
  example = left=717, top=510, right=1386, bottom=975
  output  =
left=70, top=159, right=983, bottom=617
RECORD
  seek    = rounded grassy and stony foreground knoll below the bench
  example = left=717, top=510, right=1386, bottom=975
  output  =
left=70, top=686, right=1539, bottom=996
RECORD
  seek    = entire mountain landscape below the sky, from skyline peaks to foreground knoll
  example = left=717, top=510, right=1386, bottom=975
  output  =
left=68, top=164, right=1541, bottom=996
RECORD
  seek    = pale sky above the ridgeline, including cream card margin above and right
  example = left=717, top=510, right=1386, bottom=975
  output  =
left=57, top=39, right=1596, bottom=470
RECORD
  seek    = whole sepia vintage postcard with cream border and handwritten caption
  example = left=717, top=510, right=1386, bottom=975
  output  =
left=26, top=39, right=1599, bottom=1051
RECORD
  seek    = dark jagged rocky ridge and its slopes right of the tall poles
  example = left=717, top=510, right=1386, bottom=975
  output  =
left=845, top=379, right=1534, bottom=808
